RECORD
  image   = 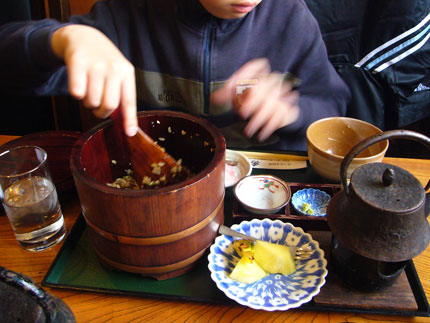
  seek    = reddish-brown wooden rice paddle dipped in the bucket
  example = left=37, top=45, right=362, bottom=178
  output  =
left=111, top=109, right=180, bottom=186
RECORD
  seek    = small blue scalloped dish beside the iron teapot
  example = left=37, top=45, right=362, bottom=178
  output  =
left=291, top=188, right=331, bottom=216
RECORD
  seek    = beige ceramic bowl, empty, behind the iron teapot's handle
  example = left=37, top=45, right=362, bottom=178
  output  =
left=306, top=117, right=388, bottom=182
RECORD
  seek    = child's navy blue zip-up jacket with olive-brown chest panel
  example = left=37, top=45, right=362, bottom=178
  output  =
left=0, top=0, right=350, bottom=150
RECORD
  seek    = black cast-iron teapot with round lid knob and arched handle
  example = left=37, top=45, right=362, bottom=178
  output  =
left=327, top=130, right=430, bottom=290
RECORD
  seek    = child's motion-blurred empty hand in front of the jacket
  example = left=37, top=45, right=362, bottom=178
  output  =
left=211, top=59, right=300, bottom=141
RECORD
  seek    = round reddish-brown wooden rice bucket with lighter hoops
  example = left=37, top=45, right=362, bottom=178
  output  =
left=71, top=111, right=225, bottom=279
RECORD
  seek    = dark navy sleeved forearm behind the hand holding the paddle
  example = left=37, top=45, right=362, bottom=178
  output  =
left=0, top=20, right=67, bottom=95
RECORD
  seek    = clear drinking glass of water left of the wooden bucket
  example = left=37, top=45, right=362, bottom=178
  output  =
left=0, top=146, right=66, bottom=251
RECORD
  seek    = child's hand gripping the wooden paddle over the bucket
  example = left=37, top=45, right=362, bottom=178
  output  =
left=51, top=25, right=137, bottom=136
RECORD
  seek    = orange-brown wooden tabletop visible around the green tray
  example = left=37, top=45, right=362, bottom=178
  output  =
left=0, top=136, right=430, bottom=323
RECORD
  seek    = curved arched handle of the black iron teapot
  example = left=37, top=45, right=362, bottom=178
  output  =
left=340, top=130, right=430, bottom=195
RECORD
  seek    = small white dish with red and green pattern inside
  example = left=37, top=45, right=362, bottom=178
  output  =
left=234, top=175, right=291, bottom=214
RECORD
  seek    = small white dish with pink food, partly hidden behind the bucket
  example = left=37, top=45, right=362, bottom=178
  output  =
left=225, top=149, right=252, bottom=188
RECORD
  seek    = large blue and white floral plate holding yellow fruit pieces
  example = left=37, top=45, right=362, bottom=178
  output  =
left=208, top=219, right=327, bottom=311
